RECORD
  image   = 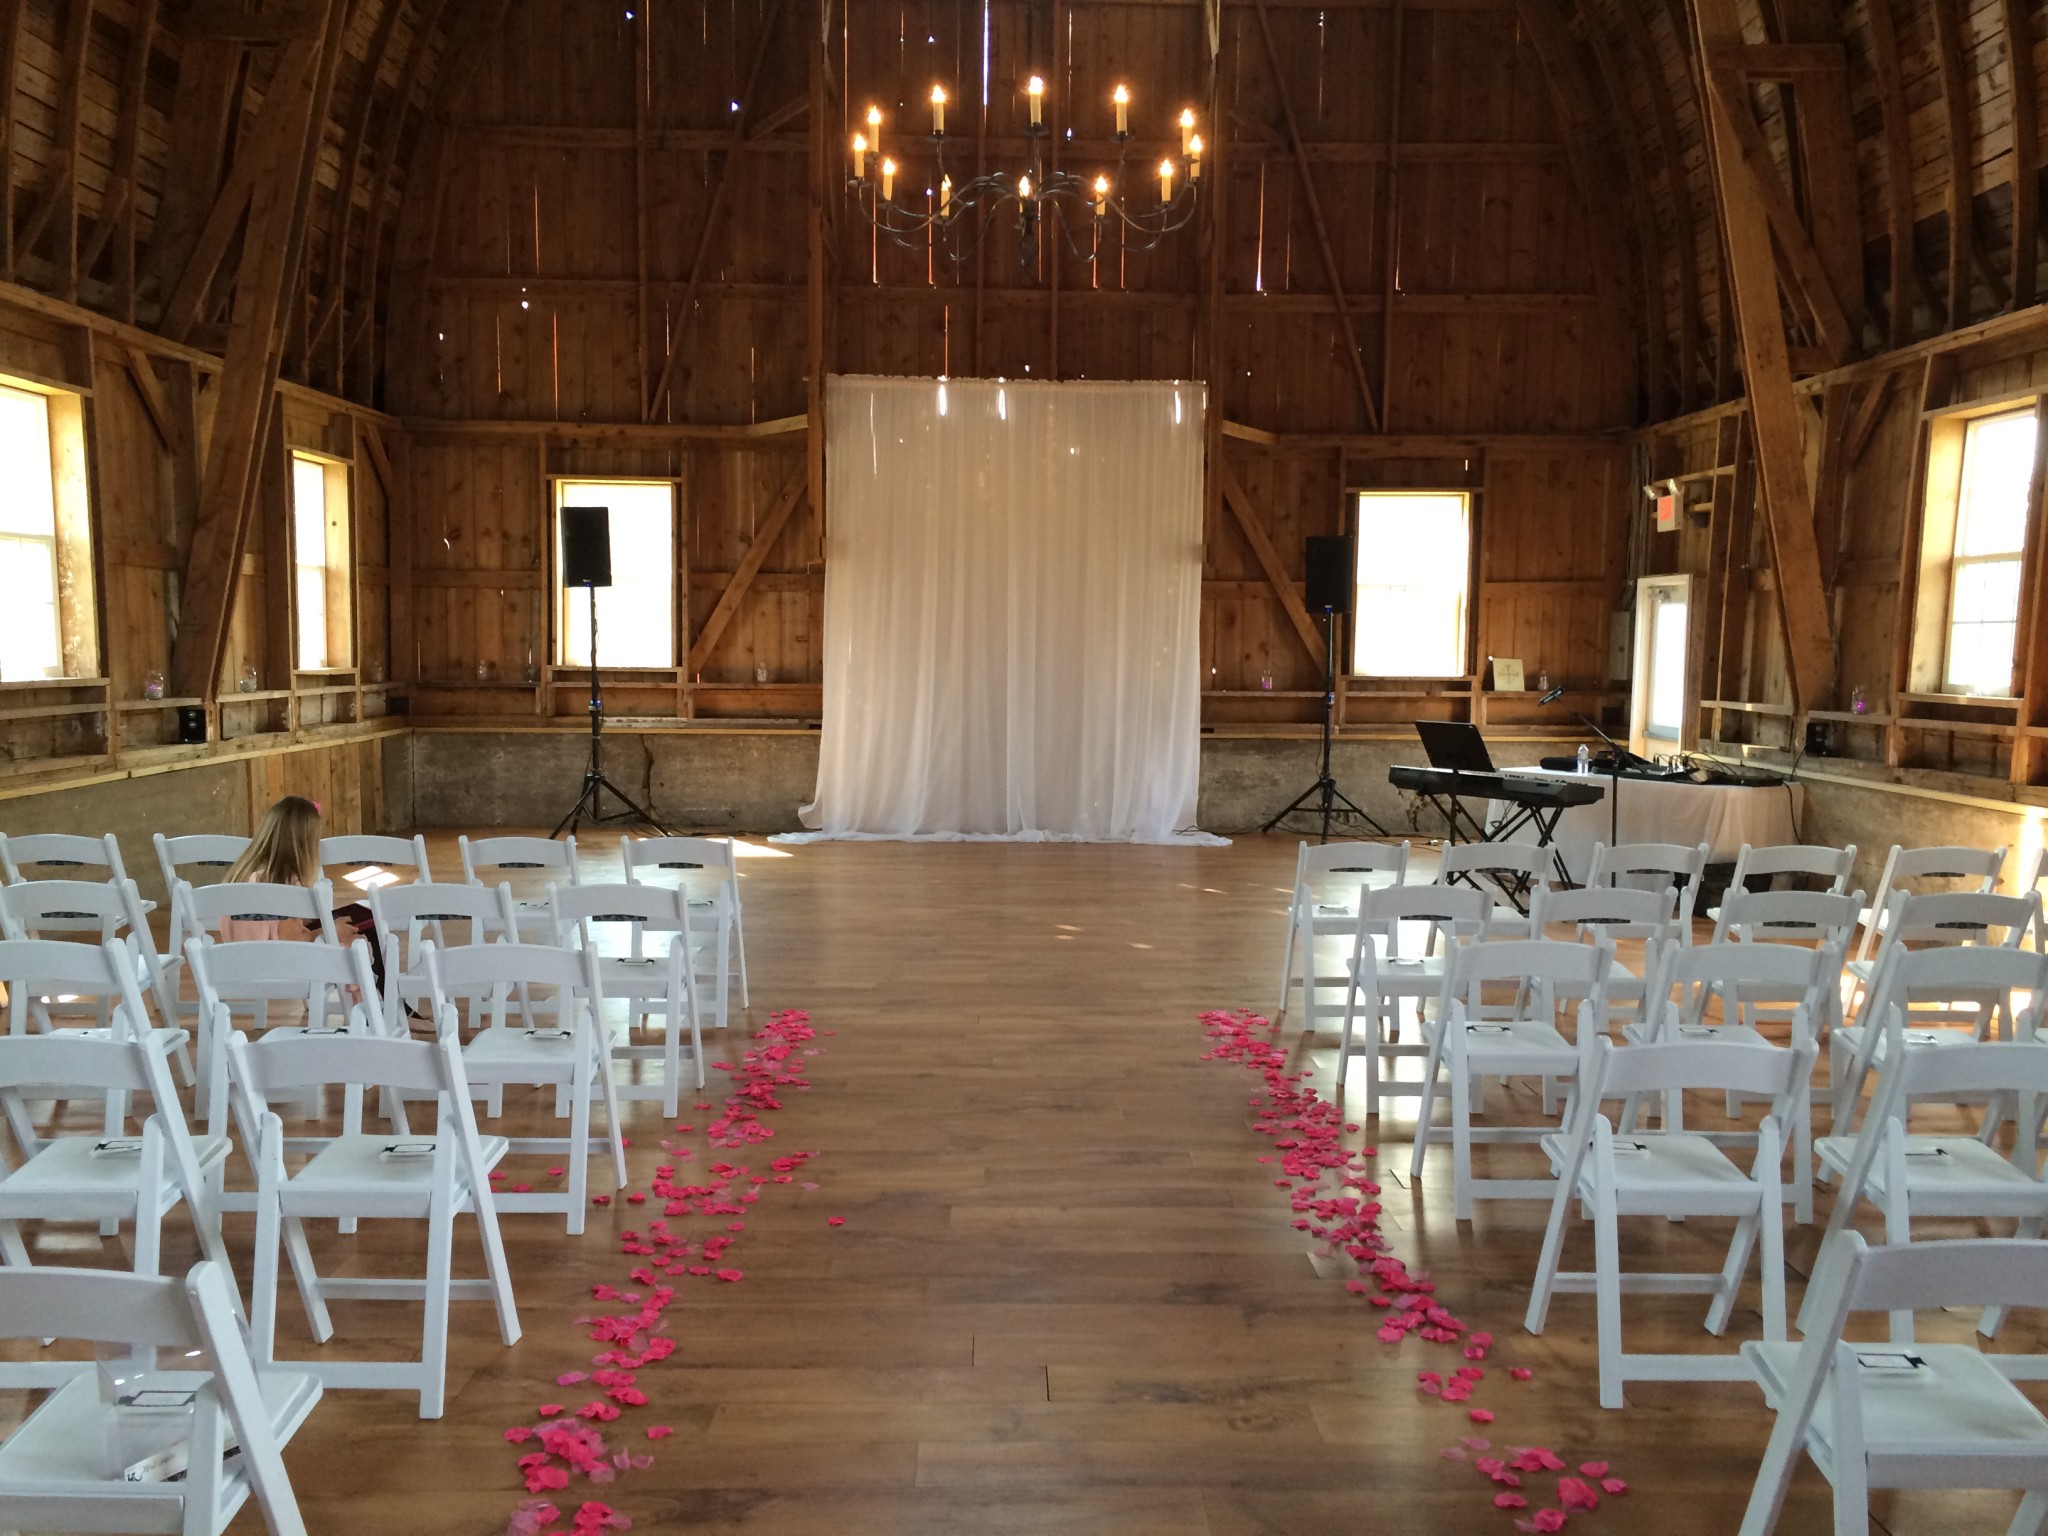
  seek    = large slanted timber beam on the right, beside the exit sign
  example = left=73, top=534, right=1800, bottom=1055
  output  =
left=1694, top=0, right=1835, bottom=711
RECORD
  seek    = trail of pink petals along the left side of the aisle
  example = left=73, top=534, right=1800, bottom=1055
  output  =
left=503, top=1008, right=844, bottom=1536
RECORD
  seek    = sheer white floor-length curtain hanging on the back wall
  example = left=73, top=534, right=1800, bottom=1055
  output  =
left=803, top=377, right=1204, bottom=842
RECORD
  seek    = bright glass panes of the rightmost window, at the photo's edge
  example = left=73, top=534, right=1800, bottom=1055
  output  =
left=1944, top=410, right=2036, bottom=694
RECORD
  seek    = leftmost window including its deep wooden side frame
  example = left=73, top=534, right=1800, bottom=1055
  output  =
left=0, top=379, right=100, bottom=682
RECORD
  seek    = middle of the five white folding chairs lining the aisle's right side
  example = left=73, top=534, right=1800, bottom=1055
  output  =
left=1409, top=938, right=1614, bottom=1221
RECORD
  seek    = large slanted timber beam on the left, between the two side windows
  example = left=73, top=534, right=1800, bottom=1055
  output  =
left=170, top=0, right=346, bottom=698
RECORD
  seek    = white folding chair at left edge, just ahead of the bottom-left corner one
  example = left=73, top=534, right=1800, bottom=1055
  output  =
left=0, top=1028, right=227, bottom=1274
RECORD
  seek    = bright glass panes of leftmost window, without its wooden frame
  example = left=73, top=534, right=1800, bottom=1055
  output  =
left=0, top=385, right=63, bottom=680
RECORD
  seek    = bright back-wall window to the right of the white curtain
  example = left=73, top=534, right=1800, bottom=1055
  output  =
left=1352, top=492, right=1473, bottom=678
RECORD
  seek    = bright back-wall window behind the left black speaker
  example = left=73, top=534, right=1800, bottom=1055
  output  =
left=555, top=479, right=676, bottom=668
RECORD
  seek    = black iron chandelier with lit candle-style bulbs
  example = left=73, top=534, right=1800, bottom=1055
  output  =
left=848, top=76, right=1202, bottom=274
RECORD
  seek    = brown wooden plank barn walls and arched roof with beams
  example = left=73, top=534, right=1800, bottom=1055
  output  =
left=0, top=0, right=2048, bottom=843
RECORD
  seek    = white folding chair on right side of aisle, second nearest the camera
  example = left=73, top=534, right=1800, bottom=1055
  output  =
left=1524, top=1036, right=1812, bottom=1409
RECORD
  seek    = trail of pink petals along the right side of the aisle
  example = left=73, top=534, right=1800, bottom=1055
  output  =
left=1202, top=1010, right=1628, bottom=1532
